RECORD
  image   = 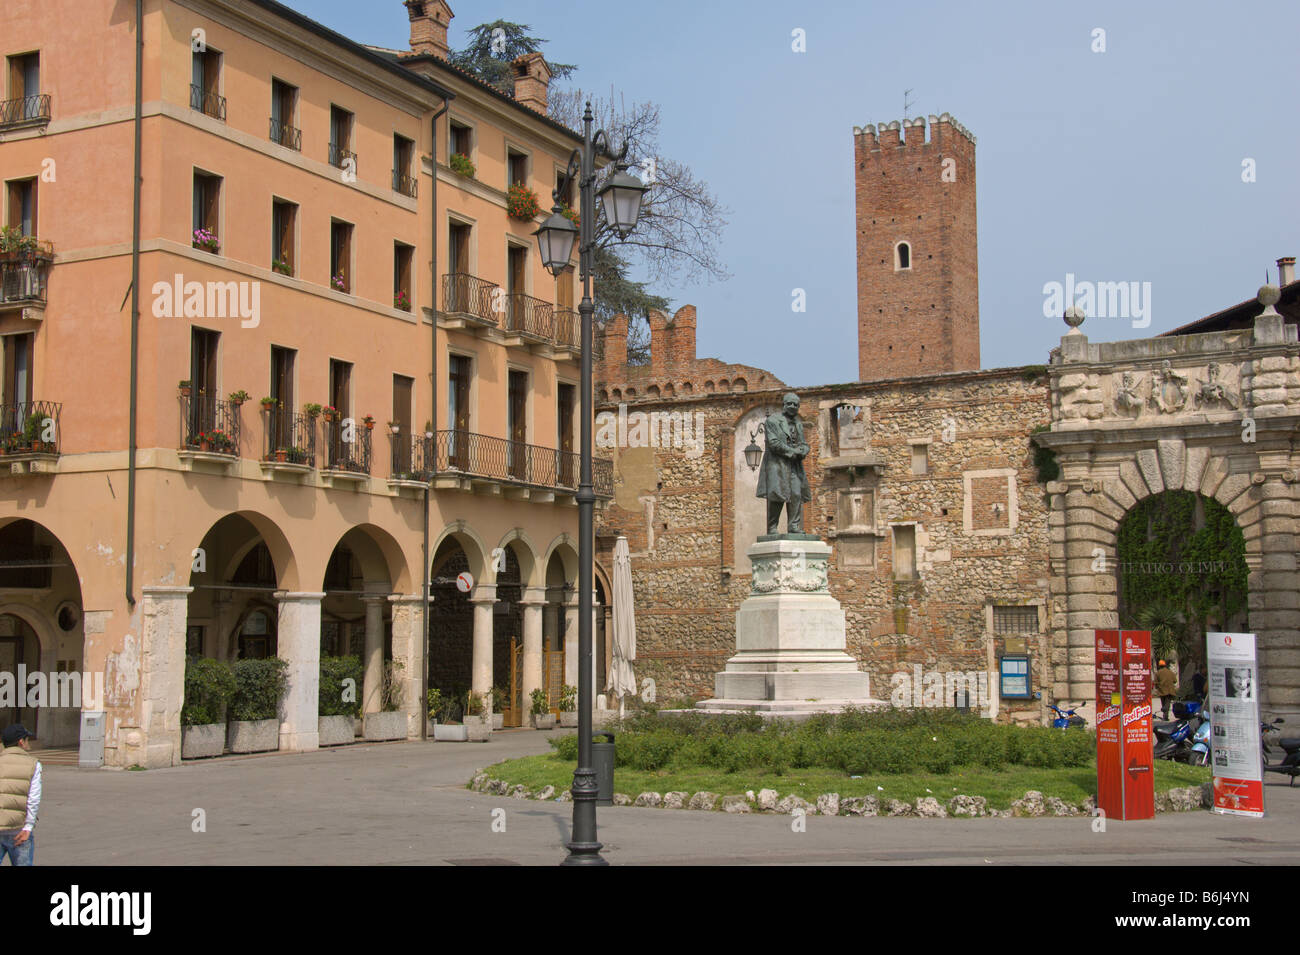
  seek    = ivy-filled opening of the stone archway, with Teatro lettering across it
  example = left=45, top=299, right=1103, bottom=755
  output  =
left=1117, top=490, right=1249, bottom=689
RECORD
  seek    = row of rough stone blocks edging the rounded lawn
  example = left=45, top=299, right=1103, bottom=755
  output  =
left=469, top=772, right=1214, bottom=819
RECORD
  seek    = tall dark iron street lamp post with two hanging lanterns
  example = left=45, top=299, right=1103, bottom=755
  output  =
left=534, top=101, right=646, bottom=865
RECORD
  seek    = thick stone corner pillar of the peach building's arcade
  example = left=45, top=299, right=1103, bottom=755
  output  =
left=135, top=586, right=194, bottom=769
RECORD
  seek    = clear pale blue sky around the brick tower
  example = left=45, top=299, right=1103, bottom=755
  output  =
left=289, top=0, right=1300, bottom=385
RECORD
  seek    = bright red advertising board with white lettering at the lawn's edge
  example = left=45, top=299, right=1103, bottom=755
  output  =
left=1093, top=630, right=1156, bottom=819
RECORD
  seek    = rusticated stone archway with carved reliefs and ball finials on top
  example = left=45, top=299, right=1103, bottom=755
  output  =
left=1035, top=298, right=1300, bottom=716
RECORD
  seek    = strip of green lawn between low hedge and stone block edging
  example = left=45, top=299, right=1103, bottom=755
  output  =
left=485, top=754, right=1210, bottom=809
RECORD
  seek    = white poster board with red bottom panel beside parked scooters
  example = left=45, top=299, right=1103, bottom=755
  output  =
left=1205, top=633, right=1264, bottom=817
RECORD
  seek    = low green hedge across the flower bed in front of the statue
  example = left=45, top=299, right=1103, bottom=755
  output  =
left=550, top=709, right=1096, bottom=776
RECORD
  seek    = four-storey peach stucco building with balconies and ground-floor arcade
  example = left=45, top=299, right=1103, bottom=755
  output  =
left=0, top=0, right=612, bottom=767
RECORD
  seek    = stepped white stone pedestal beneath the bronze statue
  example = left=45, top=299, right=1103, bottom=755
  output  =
left=697, top=537, right=884, bottom=716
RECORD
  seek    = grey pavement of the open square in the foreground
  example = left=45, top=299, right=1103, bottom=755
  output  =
left=27, top=730, right=1300, bottom=865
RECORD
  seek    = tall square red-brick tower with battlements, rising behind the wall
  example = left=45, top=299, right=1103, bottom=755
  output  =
left=853, top=113, right=980, bottom=381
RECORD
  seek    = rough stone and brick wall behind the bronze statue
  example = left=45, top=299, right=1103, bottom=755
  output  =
left=597, top=340, right=1050, bottom=719
